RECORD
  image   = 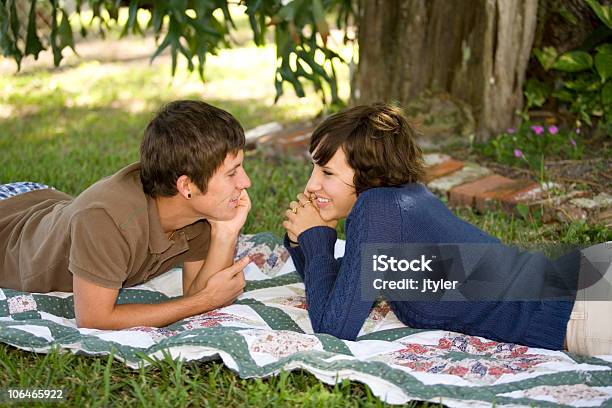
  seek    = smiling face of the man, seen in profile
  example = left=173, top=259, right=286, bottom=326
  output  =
left=190, top=150, right=251, bottom=221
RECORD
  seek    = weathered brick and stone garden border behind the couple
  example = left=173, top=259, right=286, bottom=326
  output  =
left=246, top=122, right=612, bottom=227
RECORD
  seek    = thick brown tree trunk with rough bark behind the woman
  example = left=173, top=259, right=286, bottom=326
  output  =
left=351, top=0, right=538, bottom=139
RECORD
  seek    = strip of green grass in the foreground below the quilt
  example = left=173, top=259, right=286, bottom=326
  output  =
left=0, top=346, right=406, bottom=407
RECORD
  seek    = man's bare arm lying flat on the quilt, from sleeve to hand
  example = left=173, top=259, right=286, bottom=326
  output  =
left=72, top=260, right=247, bottom=330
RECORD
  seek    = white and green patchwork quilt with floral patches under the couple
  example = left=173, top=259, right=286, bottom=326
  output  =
left=0, top=233, right=612, bottom=407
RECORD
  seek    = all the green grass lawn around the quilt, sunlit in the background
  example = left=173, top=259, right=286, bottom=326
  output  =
left=0, top=23, right=610, bottom=407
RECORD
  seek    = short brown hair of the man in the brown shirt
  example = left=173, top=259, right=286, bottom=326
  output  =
left=140, top=100, right=244, bottom=197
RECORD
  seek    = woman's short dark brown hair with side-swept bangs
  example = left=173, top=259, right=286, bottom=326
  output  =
left=310, top=103, right=424, bottom=194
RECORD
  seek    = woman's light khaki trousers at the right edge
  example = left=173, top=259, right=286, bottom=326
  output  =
left=566, top=242, right=612, bottom=356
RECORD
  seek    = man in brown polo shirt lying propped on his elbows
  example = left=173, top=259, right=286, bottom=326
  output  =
left=0, top=101, right=251, bottom=329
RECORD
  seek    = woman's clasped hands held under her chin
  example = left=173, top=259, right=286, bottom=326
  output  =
left=283, top=193, right=338, bottom=242
